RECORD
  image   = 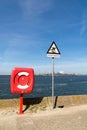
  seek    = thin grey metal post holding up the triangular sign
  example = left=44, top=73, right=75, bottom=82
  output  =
left=52, top=57, right=54, bottom=109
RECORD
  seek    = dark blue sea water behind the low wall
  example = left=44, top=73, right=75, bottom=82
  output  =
left=0, top=75, right=87, bottom=99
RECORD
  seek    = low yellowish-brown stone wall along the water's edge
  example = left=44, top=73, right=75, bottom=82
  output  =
left=0, top=95, right=87, bottom=112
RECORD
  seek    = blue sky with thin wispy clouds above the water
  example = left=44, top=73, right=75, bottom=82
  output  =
left=0, top=0, right=87, bottom=74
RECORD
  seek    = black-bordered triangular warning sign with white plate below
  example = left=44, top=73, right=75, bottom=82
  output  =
left=47, top=41, right=60, bottom=57
